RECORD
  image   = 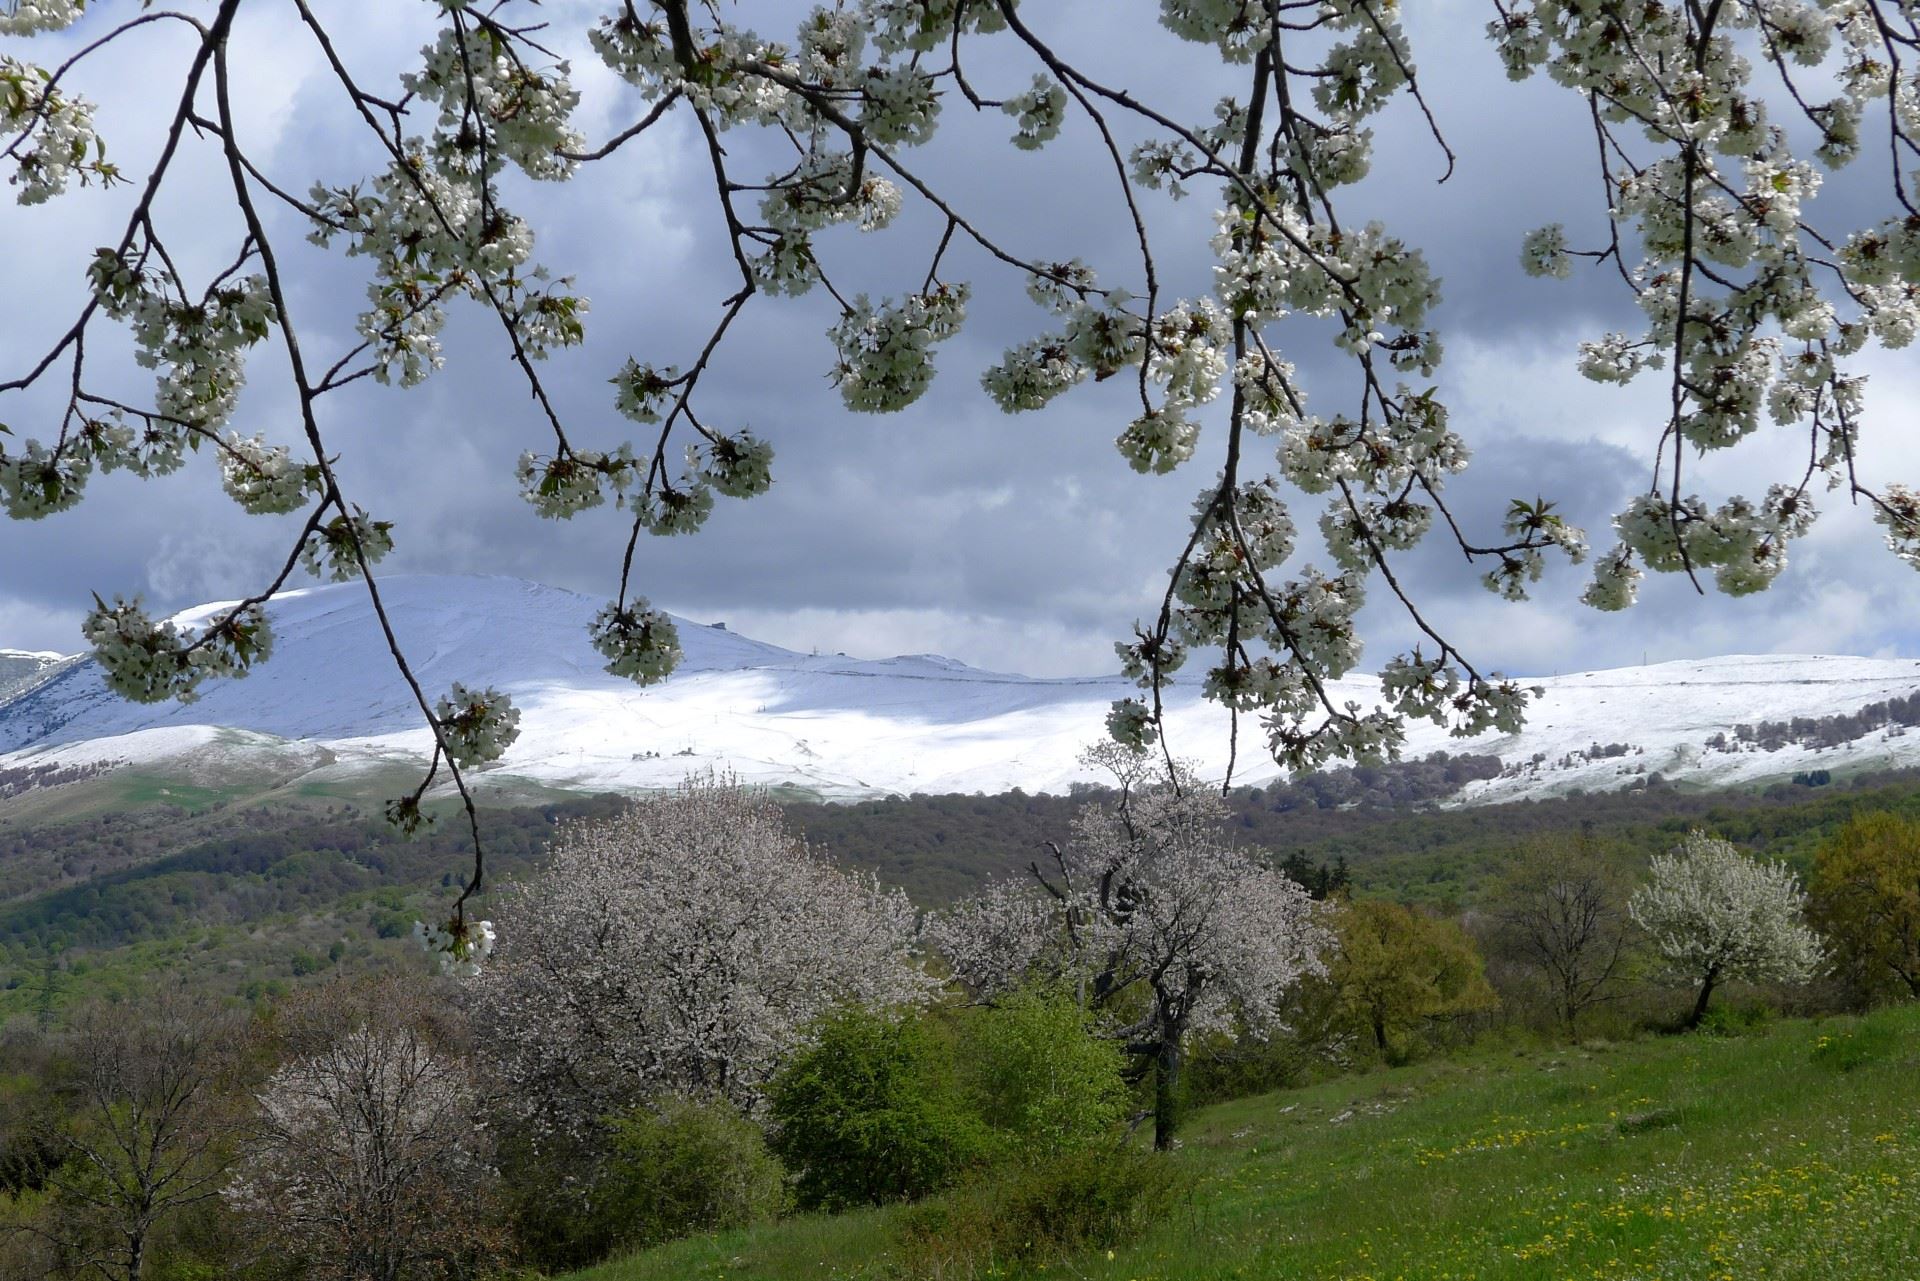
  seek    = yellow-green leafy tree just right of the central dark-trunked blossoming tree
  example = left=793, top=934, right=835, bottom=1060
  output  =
left=1327, top=899, right=1498, bottom=1052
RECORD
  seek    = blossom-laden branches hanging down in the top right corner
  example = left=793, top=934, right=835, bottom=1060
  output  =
left=1488, top=0, right=1920, bottom=609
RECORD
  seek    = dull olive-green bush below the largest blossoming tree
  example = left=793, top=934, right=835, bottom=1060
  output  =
left=597, top=1099, right=787, bottom=1248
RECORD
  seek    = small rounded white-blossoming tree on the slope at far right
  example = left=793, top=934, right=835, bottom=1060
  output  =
left=1626, top=832, right=1826, bottom=1027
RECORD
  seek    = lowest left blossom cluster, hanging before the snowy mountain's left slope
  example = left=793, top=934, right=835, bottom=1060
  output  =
left=81, top=597, right=273, bottom=703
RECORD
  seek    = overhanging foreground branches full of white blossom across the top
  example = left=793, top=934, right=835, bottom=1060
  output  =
left=11, top=0, right=1920, bottom=939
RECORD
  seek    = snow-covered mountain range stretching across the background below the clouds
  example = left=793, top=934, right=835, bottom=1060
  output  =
left=0, top=576, right=1920, bottom=801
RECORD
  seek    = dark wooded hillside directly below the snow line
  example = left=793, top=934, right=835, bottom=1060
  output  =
left=0, top=774, right=1920, bottom=1024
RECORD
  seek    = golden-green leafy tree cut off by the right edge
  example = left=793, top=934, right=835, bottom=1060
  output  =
left=1812, top=814, right=1920, bottom=997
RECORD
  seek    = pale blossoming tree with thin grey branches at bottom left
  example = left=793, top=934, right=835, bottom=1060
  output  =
left=225, top=979, right=501, bottom=1281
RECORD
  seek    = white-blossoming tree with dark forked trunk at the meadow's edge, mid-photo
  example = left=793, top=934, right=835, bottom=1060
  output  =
left=927, top=743, right=1332, bottom=1148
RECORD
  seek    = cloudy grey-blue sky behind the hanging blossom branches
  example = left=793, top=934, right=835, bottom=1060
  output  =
left=0, top=0, right=1920, bottom=674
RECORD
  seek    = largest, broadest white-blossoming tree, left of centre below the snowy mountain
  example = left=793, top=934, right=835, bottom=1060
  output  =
left=468, top=778, right=931, bottom=1135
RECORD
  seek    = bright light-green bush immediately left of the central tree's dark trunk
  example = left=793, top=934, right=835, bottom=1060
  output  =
left=960, top=987, right=1127, bottom=1156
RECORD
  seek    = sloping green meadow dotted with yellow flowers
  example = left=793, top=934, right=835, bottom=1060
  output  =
left=574, top=1006, right=1920, bottom=1281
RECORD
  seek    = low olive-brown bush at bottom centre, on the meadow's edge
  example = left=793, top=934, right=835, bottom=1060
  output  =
left=899, top=1147, right=1185, bottom=1277
